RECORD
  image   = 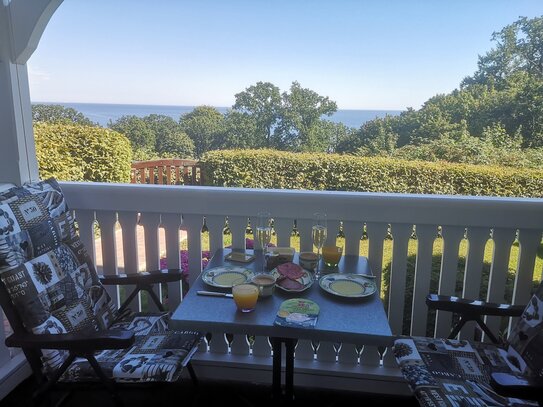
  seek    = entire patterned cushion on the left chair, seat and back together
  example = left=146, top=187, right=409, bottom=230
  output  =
left=0, top=179, right=201, bottom=381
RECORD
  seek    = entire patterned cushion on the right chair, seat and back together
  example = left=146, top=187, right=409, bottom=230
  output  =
left=394, top=283, right=543, bottom=406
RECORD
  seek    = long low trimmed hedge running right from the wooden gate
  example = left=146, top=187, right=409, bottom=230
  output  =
left=200, top=150, right=543, bottom=198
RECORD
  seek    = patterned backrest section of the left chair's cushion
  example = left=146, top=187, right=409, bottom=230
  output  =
left=0, top=179, right=115, bottom=368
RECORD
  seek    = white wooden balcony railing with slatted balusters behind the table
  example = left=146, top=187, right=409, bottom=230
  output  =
left=2, top=182, right=543, bottom=394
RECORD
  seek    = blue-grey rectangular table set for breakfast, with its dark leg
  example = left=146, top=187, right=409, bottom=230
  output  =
left=170, top=248, right=394, bottom=400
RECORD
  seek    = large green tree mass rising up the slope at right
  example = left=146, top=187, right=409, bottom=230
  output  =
left=338, top=17, right=543, bottom=167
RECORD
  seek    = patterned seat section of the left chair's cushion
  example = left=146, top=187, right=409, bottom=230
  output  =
left=61, top=313, right=202, bottom=382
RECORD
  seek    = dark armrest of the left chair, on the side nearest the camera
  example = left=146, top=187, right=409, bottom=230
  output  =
left=5, top=329, right=135, bottom=352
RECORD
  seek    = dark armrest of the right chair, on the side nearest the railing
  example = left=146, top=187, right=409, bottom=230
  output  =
left=426, top=294, right=525, bottom=317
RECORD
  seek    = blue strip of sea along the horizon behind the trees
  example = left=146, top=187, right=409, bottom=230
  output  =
left=35, top=102, right=402, bottom=128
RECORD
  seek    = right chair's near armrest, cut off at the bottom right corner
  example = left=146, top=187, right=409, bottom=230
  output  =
left=490, top=373, right=543, bottom=401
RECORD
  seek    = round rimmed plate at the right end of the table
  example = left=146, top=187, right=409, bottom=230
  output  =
left=319, top=273, right=377, bottom=298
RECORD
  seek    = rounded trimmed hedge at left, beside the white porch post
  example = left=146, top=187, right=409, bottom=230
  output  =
left=34, top=123, right=132, bottom=182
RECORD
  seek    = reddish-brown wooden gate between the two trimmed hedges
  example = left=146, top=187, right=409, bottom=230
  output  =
left=130, top=158, right=204, bottom=185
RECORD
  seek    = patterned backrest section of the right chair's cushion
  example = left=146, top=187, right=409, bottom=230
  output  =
left=508, top=282, right=543, bottom=376
